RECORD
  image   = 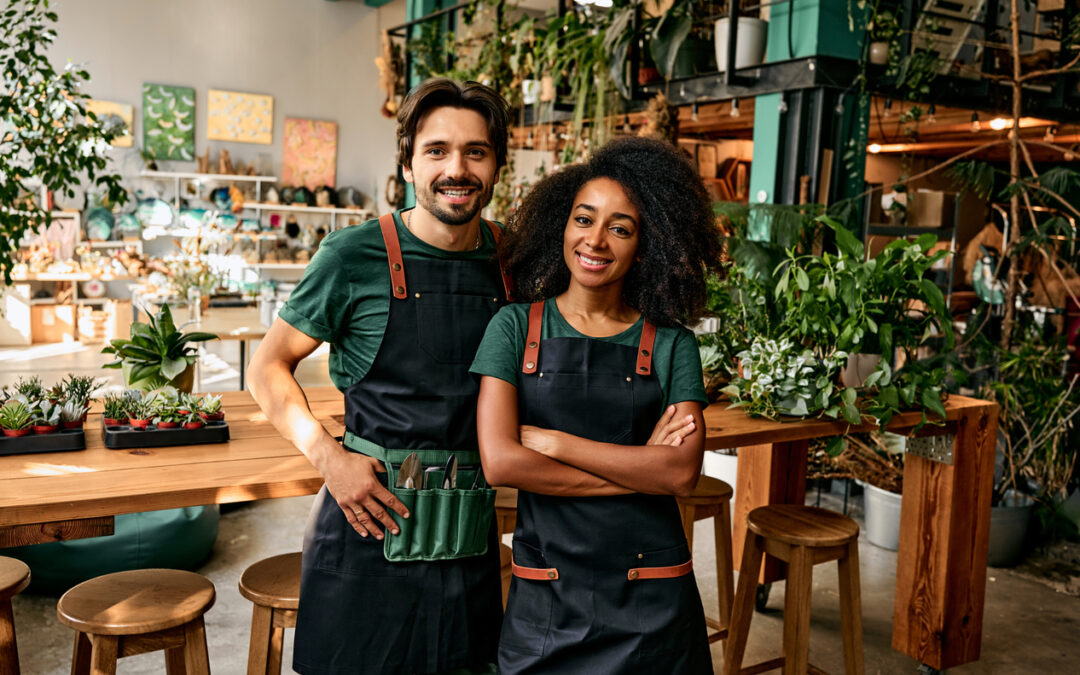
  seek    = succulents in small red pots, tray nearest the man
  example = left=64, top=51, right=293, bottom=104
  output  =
left=102, top=388, right=225, bottom=429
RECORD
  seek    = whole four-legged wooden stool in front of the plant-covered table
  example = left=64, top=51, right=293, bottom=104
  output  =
left=724, top=504, right=863, bottom=675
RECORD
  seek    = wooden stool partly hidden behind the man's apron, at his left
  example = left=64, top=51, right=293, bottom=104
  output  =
left=240, top=553, right=300, bottom=675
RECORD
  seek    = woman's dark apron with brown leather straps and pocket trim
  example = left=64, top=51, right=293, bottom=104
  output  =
left=499, top=302, right=713, bottom=675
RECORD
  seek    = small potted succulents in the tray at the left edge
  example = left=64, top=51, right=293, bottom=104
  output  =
left=0, top=375, right=102, bottom=437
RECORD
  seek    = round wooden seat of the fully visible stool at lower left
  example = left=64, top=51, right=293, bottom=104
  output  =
left=56, top=569, right=215, bottom=635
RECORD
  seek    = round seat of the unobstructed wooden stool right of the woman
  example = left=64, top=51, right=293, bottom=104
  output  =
left=746, top=504, right=859, bottom=548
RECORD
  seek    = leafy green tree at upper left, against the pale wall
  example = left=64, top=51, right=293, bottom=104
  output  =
left=0, top=0, right=126, bottom=283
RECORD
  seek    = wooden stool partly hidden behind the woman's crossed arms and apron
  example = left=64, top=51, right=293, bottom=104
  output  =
left=678, top=475, right=735, bottom=643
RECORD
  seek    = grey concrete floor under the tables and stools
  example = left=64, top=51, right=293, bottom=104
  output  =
left=0, top=345, right=1080, bottom=675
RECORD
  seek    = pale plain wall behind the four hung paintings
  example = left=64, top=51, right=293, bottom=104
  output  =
left=50, top=0, right=405, bottom=208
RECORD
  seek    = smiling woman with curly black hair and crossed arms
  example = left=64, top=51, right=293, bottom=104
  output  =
left=472, top=138, right=719, bottom=675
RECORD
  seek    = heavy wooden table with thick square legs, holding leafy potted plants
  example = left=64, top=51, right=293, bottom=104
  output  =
left=705, top=396, right=998, bottom=670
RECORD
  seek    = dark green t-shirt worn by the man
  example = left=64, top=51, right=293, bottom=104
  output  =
left=279, top=211, right=495, bottom=391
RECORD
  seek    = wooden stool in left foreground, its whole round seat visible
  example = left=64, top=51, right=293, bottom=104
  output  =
left=56, top=569, right=215, bottom=675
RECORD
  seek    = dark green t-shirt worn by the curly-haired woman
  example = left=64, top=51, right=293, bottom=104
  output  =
left=469, top=300, right=708, bottom=406
